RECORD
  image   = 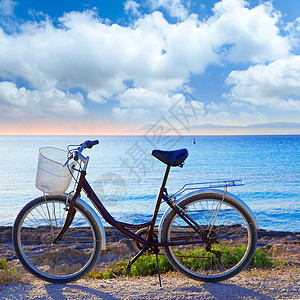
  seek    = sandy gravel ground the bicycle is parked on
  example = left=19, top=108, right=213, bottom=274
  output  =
left=0, top=267, right=300, bottom=300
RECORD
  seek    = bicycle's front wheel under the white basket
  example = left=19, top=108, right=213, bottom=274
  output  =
left=13, top=196, right=101, bottom=283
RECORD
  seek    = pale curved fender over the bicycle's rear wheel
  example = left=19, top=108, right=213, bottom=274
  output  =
left=158, top=189, right=259, bottom=242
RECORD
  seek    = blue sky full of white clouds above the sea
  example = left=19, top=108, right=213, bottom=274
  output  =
left=0, top=0, right=300, bottom=135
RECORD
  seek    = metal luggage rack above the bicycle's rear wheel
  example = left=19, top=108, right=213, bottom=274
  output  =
left=170, top=179, right=244, bottom=199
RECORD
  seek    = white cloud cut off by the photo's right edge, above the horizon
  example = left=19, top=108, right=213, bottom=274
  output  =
left=226, top=56, right=300, bottom=110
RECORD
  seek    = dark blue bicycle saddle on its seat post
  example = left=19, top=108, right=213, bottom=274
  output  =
left=151, top=149, right=189, bottom=167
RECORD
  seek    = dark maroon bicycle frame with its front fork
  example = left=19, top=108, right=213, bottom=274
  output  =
left=54, top=165, right=206, bottom=247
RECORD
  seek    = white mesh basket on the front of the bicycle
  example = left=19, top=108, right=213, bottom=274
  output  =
left=35, top=147, right=76, bottom=195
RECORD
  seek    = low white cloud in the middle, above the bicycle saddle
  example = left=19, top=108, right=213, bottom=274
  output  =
left=113, top=88, right=207, bottom=128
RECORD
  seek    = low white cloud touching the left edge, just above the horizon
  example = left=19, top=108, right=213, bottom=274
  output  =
left=0, top=81, right=85, bottom=119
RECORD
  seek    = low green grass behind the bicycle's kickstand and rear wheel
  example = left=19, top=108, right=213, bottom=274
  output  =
left=85, top=245, right=284, bottom=279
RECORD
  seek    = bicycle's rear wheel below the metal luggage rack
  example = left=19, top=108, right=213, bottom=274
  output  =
left=162, top=193, right=257, bottom=282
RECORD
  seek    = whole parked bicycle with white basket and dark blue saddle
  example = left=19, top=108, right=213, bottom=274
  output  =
left=13, top=140, right=258, bottom=284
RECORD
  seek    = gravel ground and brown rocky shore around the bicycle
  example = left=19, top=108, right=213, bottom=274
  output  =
left=0, top=227, right=300, bottom=300
